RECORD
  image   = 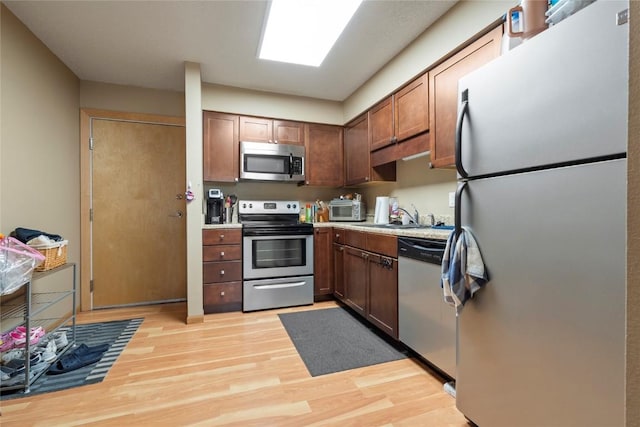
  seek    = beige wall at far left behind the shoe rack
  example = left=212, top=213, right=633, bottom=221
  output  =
left=0, top=5, right=80, bottom=311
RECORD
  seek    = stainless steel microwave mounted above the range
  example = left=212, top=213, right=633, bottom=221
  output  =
left=240, top=141, right=305, bottom=182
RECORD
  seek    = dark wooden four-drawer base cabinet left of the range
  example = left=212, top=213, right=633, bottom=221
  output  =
left=202, top=228, right=242, bottom=314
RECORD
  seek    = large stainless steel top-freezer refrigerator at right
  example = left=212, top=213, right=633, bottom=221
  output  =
left=456, top=1, right=629, bottom=427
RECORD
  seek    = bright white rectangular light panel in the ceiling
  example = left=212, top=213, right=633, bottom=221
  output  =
left=259, top=0, right=362, bottom=67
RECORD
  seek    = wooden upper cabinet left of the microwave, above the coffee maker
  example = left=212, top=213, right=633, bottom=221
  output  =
left=202, top=111, right=240, bottom=182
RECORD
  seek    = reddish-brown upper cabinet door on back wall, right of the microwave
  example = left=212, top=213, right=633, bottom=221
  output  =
left=305, top=124, right=344, bottom=187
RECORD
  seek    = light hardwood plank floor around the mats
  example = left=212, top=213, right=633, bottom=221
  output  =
left=0, top=302, right=469, bottom=427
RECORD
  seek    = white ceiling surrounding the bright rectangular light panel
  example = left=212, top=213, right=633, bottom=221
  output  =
left=3, top=0, right=457, bottom=101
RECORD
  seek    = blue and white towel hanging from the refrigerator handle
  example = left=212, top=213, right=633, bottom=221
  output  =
left=440, top=227, right=489, bottom=314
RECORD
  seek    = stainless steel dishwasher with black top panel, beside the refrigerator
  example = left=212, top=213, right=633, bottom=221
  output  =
left=398, top=237, right=457, bottom=379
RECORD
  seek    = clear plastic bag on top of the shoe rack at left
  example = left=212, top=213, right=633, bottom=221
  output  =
left=0, top=237, right=45, bottom=295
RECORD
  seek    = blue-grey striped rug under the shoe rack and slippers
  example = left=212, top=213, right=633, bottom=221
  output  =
left=0, top=318, right=144, bottom=400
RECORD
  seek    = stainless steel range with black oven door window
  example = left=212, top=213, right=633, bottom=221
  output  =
left=238, top=200, right=313, bottom=311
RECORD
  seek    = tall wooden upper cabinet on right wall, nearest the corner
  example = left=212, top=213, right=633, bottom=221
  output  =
left=344, top=113, right=396, bottom=186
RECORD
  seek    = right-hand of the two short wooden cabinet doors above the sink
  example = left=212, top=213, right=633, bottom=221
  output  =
left=393, top=73, right=429, bottom=142
